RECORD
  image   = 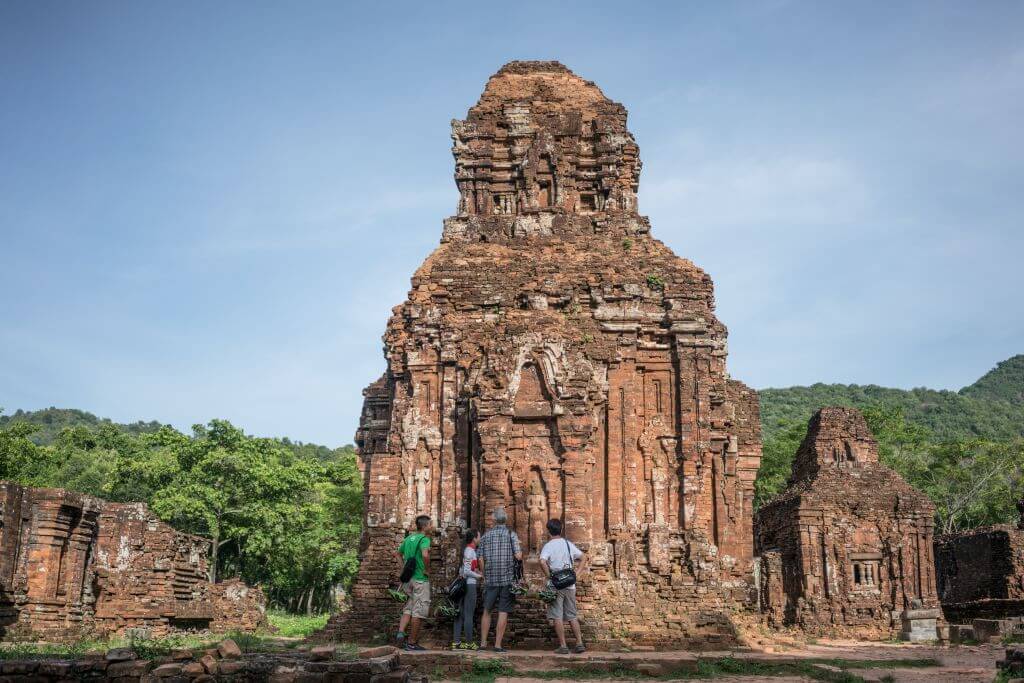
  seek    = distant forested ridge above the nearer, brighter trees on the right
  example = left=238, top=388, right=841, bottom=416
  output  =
left=761, top=355, right=1024, bottom=440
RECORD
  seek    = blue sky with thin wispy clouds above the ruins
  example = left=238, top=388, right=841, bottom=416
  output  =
left=0, top=0, right=1024, bottom=445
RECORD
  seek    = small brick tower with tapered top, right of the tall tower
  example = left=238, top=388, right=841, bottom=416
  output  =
left=755, top=408, right=940, bottom=640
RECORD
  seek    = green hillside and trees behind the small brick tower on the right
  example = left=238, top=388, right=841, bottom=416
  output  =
left=755, top=355, right=1024, bottom=532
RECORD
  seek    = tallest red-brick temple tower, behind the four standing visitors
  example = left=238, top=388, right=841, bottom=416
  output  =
left=329, top=61, right=761, bottom=645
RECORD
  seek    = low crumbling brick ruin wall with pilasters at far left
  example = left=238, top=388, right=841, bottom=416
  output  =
left=0, top=481, right=265, bottom=640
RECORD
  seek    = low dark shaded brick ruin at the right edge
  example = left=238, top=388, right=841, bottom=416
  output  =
left=935, top=502, right=1024, bottom=624
